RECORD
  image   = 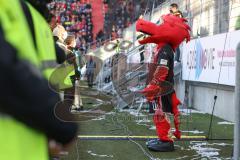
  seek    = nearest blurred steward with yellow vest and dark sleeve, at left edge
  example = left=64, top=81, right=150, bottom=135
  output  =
left=0, top=0, right=77, bottom=160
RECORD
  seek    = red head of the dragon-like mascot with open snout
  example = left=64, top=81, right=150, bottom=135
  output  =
left=136, top=14, right=190, bottom=50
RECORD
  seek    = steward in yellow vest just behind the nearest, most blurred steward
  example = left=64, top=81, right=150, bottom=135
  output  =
left=23, top=0, right=66, bottom=90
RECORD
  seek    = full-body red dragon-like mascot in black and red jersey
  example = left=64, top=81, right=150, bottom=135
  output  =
left=136, top=14, right=190, bottom=152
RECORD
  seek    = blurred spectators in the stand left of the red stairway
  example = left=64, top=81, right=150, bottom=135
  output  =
left=48, top=0, right=93, bottom=52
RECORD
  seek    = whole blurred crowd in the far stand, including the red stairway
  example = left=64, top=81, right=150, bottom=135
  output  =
left=48, top=0, right=165, bottom=53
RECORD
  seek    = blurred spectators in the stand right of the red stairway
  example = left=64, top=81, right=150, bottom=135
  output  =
left=102, top=0, right=165, bottom=42
